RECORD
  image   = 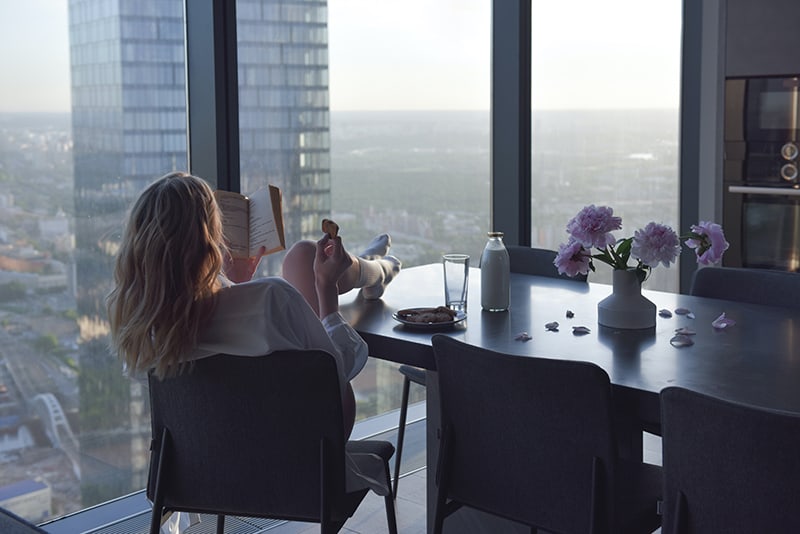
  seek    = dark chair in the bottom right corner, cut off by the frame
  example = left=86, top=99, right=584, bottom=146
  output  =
left=661, top=386, right=800, bottom=534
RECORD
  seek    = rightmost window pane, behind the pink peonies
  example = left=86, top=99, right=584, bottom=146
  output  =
left=531, top=0, right=689, bottom=291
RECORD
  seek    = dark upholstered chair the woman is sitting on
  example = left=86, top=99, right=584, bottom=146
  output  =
left=147, top=351, right=397, bottom=534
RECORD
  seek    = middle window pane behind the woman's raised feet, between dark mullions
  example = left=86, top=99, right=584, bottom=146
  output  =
left=237, top=0, right=491, bottom=418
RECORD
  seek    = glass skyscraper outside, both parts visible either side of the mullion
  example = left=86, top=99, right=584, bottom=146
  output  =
left=69, top=0, right=330, bottom=506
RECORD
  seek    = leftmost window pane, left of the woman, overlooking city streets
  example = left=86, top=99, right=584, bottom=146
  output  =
left=0, top=0, right=186, bottom=521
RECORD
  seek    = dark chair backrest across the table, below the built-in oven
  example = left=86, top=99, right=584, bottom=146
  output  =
left=690, top=267, right=800, bottom=310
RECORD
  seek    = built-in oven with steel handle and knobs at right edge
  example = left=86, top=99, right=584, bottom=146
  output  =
left=723, top=75, right=800, bottom=272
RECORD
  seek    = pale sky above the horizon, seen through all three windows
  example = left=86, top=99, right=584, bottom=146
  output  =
left=0, top=0, right=681, bottom=112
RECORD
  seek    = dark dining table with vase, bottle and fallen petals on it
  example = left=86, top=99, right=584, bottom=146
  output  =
left=341, top=264, right=800, bottom=528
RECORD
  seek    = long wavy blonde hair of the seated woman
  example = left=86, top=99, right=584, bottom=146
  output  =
left=107, top=172, right=224, bottom=377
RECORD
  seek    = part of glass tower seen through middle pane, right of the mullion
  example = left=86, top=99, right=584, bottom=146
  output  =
left=236, top=0, right=331, bottom=274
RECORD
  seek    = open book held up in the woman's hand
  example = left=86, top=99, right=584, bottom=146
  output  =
left=214, top=185, right=286, bottom=258
